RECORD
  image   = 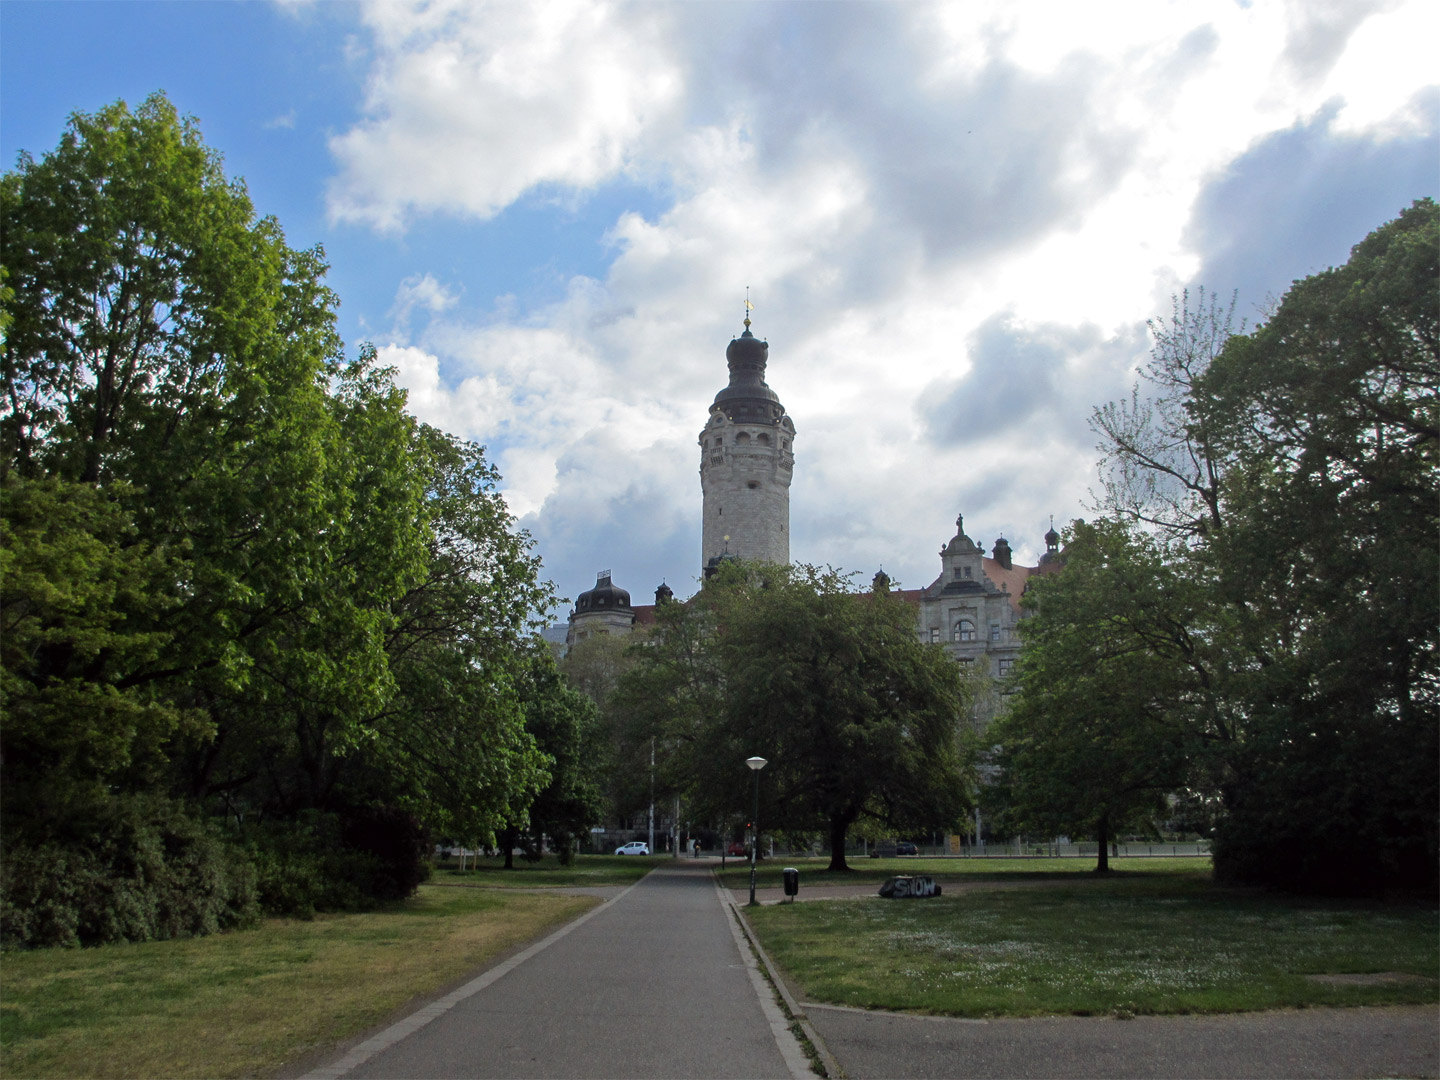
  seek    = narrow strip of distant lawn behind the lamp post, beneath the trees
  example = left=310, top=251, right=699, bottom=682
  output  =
left=716, top=855, right=1210, bottom=894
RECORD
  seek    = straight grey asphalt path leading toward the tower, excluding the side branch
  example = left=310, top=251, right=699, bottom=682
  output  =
left=310, top=861, right=812, bottom=1080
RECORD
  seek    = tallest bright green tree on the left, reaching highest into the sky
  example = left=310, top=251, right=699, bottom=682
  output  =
left=0, top=95, right=400, bottom=817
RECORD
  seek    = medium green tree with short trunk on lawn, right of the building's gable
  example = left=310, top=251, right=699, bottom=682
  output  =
left=988, top=521, right=1233, bottom=873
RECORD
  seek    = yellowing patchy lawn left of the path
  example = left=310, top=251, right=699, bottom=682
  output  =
left=0, top=886, right=596, bottom=1077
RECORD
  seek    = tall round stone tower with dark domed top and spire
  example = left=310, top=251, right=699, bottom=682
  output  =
left=700, top=317, right=795, bottom=577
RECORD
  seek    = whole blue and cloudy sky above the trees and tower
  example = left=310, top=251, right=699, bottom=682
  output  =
left=0, top=0, right=1440, bottom=618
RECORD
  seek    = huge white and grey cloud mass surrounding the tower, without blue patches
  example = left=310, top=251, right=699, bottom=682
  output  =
left=331, top=0, right=1436, bottom=598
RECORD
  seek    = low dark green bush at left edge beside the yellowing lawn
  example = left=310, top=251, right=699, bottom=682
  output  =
left=0, top=796, right=258, bottom=949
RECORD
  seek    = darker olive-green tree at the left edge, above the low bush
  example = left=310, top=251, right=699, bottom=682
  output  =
left=0, top=474, right=202, bottom=842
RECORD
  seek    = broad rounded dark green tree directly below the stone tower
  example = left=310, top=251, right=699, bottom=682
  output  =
left=622, top=563, right=973, bottom=870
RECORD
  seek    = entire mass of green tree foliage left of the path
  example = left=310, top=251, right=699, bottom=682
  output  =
left=0, top=95, right=567, bottom=938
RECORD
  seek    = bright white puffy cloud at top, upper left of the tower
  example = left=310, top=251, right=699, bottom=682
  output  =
left=330, top=0, right=680, bottom=230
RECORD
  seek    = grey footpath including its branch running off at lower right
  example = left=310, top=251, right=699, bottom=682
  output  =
left=305, top=860, right=1440, bottom=1080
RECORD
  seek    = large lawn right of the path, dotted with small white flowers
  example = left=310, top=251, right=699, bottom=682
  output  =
left=747, top=860, right=1440, bottom=1018
